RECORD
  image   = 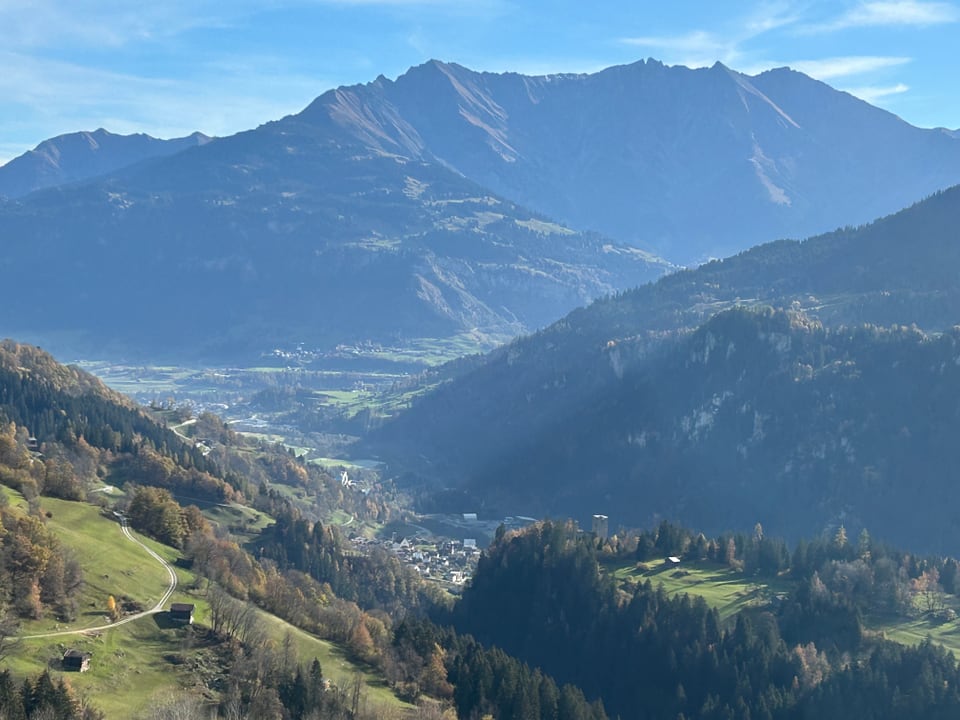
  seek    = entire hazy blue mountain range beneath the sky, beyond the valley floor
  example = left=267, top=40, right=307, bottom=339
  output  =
left=0, top=61, right=960, bottom=362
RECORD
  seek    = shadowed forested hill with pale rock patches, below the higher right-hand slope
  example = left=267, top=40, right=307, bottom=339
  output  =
left=378, top=310, right=960, bottom=552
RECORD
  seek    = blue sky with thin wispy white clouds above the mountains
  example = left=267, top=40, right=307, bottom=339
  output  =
left=0, top=0, right=960, bottom=163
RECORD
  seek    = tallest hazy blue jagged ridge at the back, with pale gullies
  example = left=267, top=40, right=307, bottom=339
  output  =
left=303, top=60, right=960, bottom=263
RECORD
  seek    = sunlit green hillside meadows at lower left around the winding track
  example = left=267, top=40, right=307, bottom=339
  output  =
left=0, top=488, right=404, bottom=720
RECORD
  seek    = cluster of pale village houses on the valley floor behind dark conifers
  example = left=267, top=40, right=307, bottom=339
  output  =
left=351, top=535, right=480, bottom=586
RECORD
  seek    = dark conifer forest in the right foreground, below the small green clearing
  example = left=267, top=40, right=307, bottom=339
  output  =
left=446, top=522, right=960, bottom=720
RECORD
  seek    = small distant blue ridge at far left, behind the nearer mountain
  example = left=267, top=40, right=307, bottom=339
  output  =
left=0, top=128, right=210, bottom=198
